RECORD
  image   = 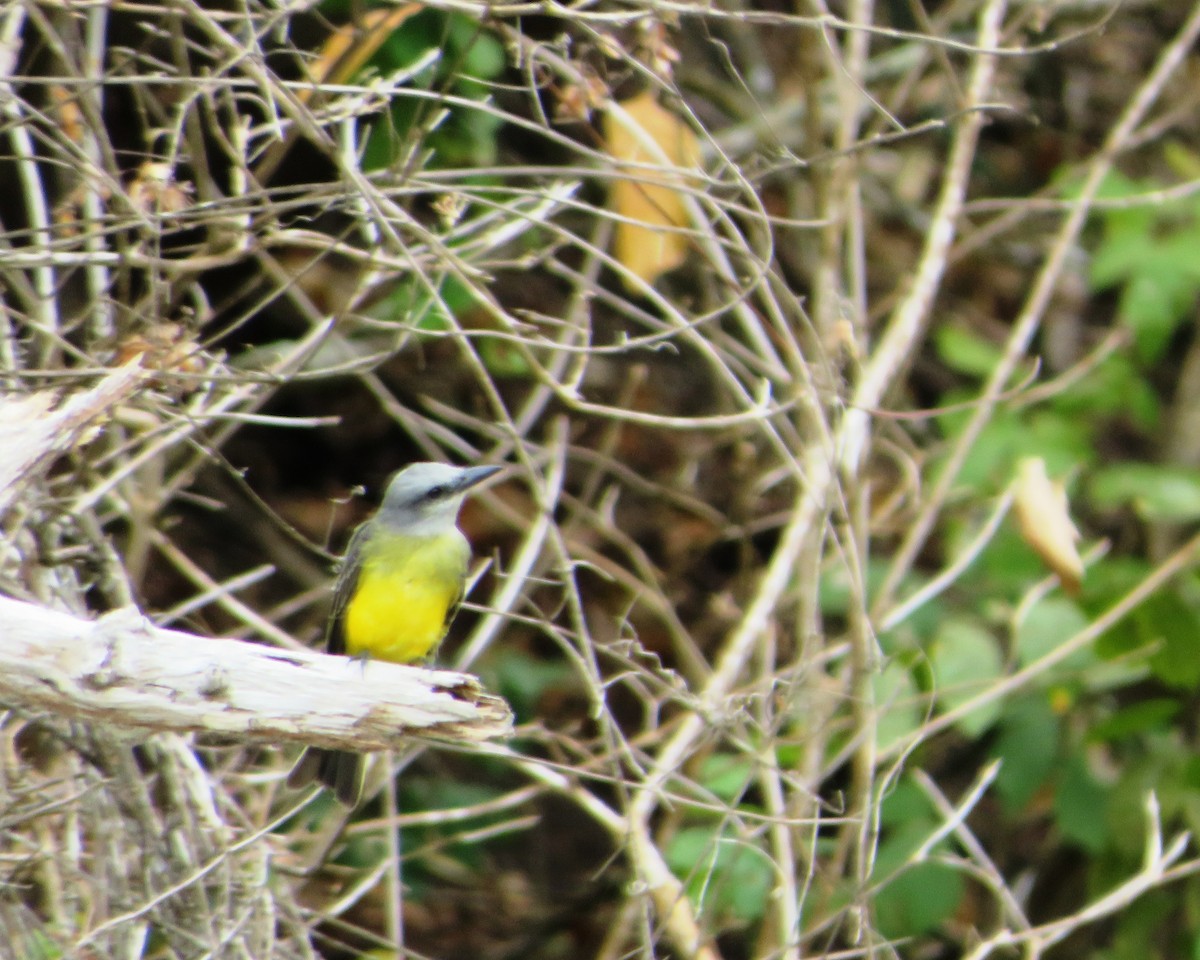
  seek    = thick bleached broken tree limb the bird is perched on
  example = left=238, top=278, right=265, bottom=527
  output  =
left=0, top=598, right=512, bottom=751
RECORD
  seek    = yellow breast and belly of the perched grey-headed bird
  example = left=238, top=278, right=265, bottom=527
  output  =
left=343, top=530, right=469, bottom=664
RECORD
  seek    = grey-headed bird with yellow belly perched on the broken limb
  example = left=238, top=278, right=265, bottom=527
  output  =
left=287, top=463, right=500, bottom=809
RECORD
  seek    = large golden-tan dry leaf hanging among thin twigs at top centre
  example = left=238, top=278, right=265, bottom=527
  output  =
left=604, top=91, right=700, bottom=288
